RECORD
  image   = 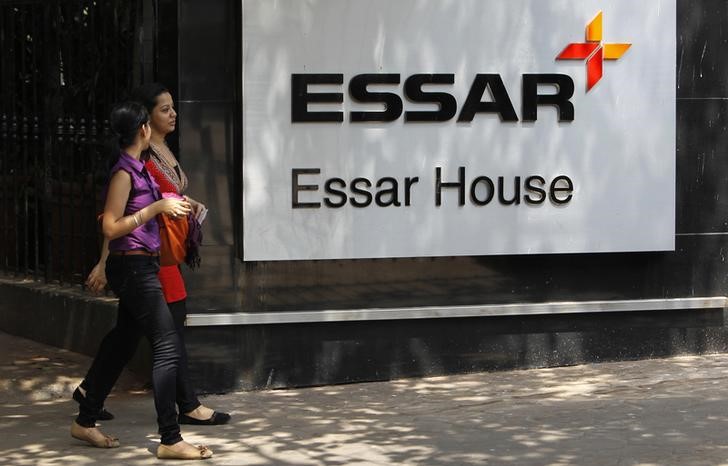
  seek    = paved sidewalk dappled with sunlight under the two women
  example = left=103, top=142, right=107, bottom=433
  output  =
left=0, top=333, right=728, bottom=466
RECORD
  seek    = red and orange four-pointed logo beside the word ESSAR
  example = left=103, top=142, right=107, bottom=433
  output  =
left=556, top=11, right=632, bottom=92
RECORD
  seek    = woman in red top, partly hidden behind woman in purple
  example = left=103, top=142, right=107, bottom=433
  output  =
left=80, top=83, right=230, bottom=425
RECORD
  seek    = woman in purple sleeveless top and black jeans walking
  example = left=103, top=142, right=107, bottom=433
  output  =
left=71, top=102, right=212, bottom=459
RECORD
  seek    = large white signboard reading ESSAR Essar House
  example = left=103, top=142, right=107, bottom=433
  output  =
left=243, top=0, right=676, bottom=260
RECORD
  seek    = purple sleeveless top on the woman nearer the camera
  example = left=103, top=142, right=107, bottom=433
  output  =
left=109, top=152, right=162, bottom=252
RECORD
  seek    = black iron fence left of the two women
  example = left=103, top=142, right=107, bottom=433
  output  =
left=0, top=0, right=157, bottom=284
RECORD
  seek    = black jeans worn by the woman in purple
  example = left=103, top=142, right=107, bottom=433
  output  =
left=76, top=255, right=183, bottom=445
